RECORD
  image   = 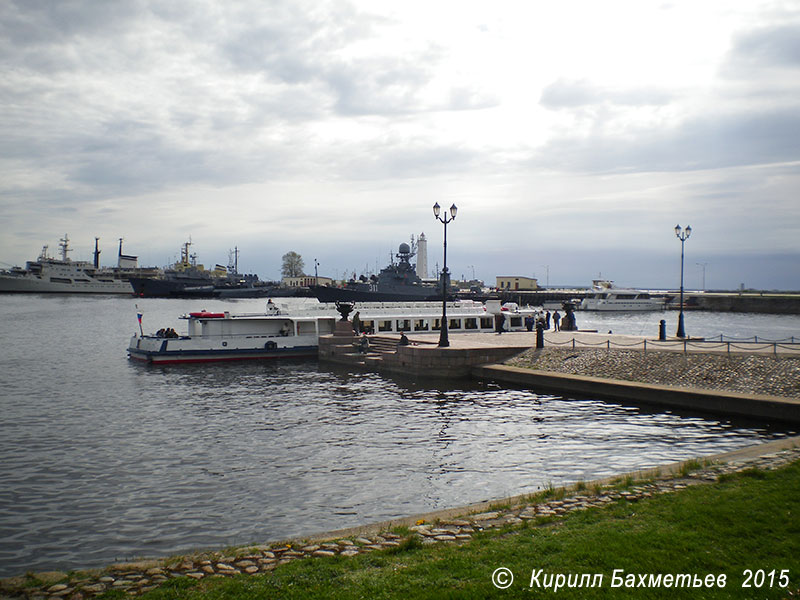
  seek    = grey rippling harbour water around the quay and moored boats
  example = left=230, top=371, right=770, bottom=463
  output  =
left=0, top=295, right=800, bottom=576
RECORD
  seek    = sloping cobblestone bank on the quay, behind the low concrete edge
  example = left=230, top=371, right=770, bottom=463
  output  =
left=505, top=348, right=800, bottom=398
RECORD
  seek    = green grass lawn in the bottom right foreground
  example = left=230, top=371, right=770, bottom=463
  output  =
left=109, top=463, right=800, bottom=600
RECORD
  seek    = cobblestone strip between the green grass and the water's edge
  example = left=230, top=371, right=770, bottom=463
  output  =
left=0, top=447, right=800, bottom=600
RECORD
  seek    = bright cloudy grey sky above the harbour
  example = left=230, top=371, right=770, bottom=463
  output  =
left=0, top=0, right=800, bottom=290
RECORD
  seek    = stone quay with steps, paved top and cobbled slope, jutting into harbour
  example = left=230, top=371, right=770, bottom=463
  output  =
left=320, top=331, right=800, bottom=423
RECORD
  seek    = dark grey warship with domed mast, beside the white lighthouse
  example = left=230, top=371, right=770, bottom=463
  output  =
left=311, top=243, right=442, bottom=302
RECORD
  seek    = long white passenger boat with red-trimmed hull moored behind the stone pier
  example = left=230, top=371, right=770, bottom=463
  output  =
left=128, top=301, right=532, bottom=364
